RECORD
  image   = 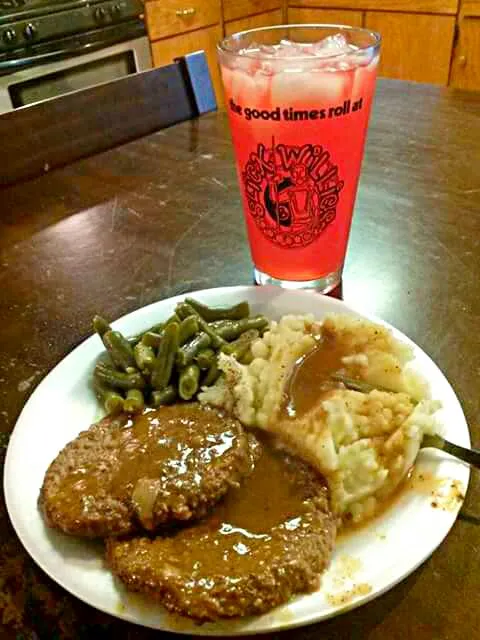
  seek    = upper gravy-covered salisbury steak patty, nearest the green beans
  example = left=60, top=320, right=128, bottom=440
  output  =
left=39, top=403, right=260, bottom=537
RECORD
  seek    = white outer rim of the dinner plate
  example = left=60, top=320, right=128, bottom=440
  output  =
left=4, top=285, right=470, bottom=636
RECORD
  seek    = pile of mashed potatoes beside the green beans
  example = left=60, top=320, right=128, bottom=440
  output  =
left=200, top=315, right=439, bottom=522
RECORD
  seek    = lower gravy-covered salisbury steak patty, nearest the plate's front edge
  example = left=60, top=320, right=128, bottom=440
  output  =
left=107, top=446, right=335, bottom=621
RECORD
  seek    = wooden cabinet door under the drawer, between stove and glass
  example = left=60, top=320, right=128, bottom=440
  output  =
left=152, top=25, right=223, bottom=105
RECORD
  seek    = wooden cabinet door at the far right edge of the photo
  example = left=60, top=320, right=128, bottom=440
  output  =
left=450, top=18, right=480, bottom=91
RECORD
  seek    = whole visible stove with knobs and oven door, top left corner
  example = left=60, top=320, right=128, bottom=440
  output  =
left=0, top=0, right=152, bottom=114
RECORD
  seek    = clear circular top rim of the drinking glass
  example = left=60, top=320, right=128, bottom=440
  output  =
left=217, top=22, right=382, bottom=60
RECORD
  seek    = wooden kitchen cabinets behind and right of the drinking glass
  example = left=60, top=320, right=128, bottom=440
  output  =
left=287, top=0, right=480, bottom=91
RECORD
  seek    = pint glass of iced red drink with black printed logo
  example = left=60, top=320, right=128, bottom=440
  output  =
left=219, top=25, right=379, bottom=291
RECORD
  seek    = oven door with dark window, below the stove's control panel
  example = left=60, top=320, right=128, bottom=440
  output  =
left=0, top=29, right=152, bottom=113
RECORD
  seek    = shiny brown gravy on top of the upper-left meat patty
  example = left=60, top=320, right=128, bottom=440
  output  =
left=58, top=404, right=239, bottom=508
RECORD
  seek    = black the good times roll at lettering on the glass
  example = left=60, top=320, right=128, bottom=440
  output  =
left=229, top=98, right=363, bottom=122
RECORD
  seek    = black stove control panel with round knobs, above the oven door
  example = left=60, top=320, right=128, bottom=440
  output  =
left=0, top=0, right=145, bottom=74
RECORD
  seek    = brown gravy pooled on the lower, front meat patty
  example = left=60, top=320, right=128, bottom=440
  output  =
left=140, top=439, right=327, bottom=576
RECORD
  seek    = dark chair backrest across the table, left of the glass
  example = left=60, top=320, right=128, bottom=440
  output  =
left=0, top=51, right=217, bottom=185
